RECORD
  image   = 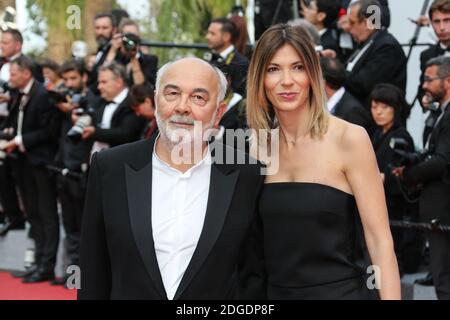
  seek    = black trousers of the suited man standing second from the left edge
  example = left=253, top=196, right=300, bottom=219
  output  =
left=11, top=159, right=59, bottom=270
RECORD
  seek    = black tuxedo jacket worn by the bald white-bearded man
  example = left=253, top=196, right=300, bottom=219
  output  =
left=78, top=137, right=264, bottom=300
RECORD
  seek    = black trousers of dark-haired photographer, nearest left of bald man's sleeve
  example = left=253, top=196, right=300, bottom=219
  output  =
left=57, top=175, right=85, bottom=265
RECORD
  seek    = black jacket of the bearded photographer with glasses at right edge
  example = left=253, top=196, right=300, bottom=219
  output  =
left=404, top=107, right=450, bottom=225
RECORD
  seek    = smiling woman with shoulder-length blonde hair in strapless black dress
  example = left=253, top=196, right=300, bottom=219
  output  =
left=247, top=24, right=400, bottom=299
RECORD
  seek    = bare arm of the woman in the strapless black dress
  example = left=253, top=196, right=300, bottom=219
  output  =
left=342, top=125, right=401, bottom=299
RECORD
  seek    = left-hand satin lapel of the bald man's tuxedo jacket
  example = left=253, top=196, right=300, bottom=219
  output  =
left=125, top=139, right=167, bottom=299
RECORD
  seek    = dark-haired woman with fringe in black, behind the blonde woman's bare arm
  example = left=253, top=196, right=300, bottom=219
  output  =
left=370, top=83, right=414, bottom=272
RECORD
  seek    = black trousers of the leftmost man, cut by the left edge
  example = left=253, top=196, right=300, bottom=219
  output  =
left=0, top=158, right=24, bottom=222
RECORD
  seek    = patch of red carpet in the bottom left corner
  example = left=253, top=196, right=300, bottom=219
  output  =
left=0, top=272, right=77, bottom=300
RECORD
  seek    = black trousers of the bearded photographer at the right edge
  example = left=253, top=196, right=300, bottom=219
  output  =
left=427, top=232, right=450, bottom=300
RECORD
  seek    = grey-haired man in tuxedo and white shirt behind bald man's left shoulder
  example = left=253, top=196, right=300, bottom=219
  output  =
left=78, top=62, right=145, bottom=153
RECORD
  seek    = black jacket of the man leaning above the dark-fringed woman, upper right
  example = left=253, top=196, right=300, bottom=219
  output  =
left=345, top=30, right=407, bottom=108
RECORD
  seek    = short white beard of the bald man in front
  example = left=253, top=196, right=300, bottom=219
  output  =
left=155, top=108, right=217, bottom=149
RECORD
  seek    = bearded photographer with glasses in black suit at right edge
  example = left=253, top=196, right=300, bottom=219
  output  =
left=394, top=56, right=450, bottom=300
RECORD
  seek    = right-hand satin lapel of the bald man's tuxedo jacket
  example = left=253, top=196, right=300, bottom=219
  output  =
left=174, top=163, right=239, bottom=299
